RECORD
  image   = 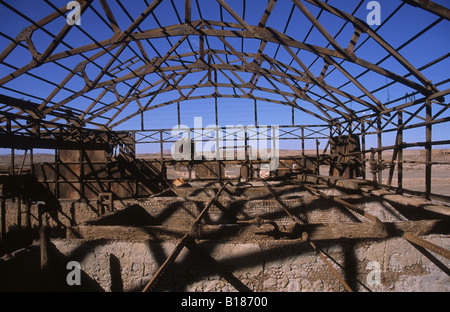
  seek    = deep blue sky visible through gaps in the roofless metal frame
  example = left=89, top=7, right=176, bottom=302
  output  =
left=0, top=0, right=450, bottom=154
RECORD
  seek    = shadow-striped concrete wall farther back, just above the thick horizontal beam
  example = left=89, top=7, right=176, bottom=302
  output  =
left=5, top=180, right=448, bottom=236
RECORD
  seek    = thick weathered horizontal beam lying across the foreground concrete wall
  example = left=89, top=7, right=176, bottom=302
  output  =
left=67, top=220, right=450, bottom=242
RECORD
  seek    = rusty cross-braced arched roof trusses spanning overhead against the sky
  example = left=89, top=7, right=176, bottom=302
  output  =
left=0, top=0, right=448, bottom=129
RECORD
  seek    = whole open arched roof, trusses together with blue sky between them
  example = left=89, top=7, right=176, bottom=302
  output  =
left=0, top=0, right=449, bottom=130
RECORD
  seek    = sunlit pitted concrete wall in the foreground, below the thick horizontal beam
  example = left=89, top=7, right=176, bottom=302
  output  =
left=46, top=235, right=450, bottom=291
